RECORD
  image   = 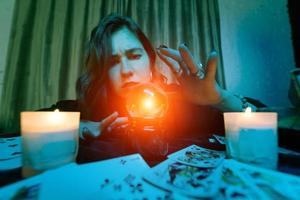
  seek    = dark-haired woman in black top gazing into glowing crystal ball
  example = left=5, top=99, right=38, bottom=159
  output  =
left=50, top=15, right=254, bottom=160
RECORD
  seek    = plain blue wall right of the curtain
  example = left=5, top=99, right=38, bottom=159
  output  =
left=219, top=0, right=295, bottom=106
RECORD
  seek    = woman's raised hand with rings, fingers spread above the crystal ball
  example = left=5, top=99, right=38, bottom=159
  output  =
left=157, top=44, right=223, bottom=105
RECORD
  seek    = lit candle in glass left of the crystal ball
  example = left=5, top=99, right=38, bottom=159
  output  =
left=21, top=110, right=80, bottom=177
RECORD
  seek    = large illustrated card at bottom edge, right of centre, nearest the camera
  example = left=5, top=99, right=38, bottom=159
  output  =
left=144, top=159, right=222, bottom=198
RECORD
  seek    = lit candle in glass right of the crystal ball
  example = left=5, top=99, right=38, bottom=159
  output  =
left=224, top=107, right=278, bottom=169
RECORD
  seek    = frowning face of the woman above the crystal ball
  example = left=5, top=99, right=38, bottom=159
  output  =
left=108, top=27, right=151, bottom=97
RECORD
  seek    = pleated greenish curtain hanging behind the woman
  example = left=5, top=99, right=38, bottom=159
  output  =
left=0, top=0, right=225, bottom=132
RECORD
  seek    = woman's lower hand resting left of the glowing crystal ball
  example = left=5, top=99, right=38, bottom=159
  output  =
left=79, top=112, right=128, bottom=139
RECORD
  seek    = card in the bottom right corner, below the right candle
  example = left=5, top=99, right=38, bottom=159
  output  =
left=231, top=161, right=300, bottom=199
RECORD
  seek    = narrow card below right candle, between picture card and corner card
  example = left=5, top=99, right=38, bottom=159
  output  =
left=220, top=160, right=265, bottom=199
